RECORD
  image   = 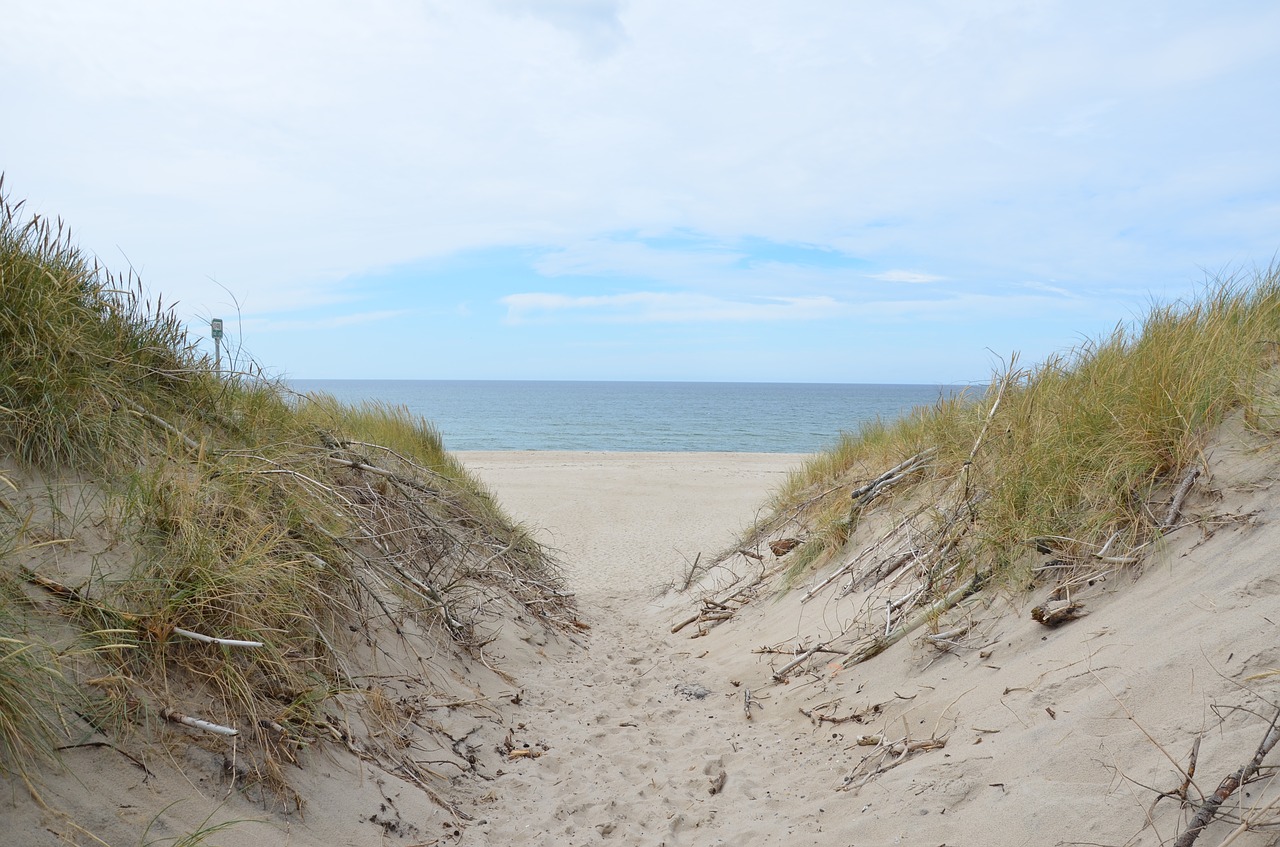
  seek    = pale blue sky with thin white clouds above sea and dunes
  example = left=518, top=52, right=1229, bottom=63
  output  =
left=0, top=0, right=1280, bottom=384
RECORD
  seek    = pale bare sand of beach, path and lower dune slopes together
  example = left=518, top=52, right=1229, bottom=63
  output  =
left=10, top=440, right=1280, bottom=847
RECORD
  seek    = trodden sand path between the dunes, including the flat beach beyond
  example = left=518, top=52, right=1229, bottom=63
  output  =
left=463, top=453, right=835, bottom=844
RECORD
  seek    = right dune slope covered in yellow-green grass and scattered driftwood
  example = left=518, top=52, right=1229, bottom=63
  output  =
left=708, top=270, right=1280, bottom=673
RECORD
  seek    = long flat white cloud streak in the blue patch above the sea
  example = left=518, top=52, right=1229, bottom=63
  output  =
left=499, top=292, right=849, bottom=324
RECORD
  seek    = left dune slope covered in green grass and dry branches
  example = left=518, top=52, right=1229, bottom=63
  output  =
left=0, top=189, right=572, bottom=803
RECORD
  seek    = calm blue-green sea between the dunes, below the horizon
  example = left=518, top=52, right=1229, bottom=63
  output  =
left=289, top=380, right=965, bottom=453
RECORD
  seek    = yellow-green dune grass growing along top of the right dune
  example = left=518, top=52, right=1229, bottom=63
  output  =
left=746, top=269, right=1280, bottom=603
